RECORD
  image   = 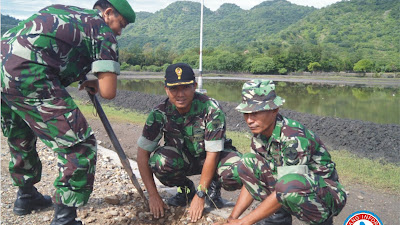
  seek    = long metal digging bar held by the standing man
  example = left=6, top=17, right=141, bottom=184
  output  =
left=83, top=81, right=149, bottom=209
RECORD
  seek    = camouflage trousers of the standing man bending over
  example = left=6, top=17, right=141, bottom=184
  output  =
left=1, top=94, right=97, bottom=207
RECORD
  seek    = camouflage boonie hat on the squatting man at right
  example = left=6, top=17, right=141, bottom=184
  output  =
left=236, top=80, right=285, bottom=113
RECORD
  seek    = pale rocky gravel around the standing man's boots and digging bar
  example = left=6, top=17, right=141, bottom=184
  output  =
left=1, top=136, right=224, bottom=225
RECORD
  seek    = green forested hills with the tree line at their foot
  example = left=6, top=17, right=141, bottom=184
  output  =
left=1, top=0, right=400, bottom=74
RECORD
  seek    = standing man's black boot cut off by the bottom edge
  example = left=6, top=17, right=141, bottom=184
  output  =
left=50, top=204, right=82, bottom=225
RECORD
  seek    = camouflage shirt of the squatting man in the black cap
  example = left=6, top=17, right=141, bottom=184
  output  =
left=138, top=93, right=226, bottom=157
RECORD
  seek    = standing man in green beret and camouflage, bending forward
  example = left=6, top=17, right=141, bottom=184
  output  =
left=1, top=0, right=135, bottom=225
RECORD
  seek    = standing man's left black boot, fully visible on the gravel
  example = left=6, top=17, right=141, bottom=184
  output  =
left=13, top=186, right=53, bottom=216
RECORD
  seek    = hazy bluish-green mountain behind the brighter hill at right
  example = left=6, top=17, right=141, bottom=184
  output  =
left=119, top=0, right=316, bottom=51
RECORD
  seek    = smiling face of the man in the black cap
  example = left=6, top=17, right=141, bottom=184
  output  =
left=164, top=84, right=197, bottom=114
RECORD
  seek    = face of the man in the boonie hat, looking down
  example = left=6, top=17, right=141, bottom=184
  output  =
left=243, top=109, right=278, bottom=137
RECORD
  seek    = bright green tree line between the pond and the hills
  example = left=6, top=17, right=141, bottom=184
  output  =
left=120, top=40, right=400, bottom=74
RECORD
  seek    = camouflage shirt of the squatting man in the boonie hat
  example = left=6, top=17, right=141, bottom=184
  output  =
left=251, top=114, right=336, bottom=178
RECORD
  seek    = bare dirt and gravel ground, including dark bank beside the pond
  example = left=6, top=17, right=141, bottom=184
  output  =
left=1, top=88, right=400, bottom=225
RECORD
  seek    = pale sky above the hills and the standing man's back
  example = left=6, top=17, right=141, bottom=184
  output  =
left=1, top=0, right=340, bottom=19
